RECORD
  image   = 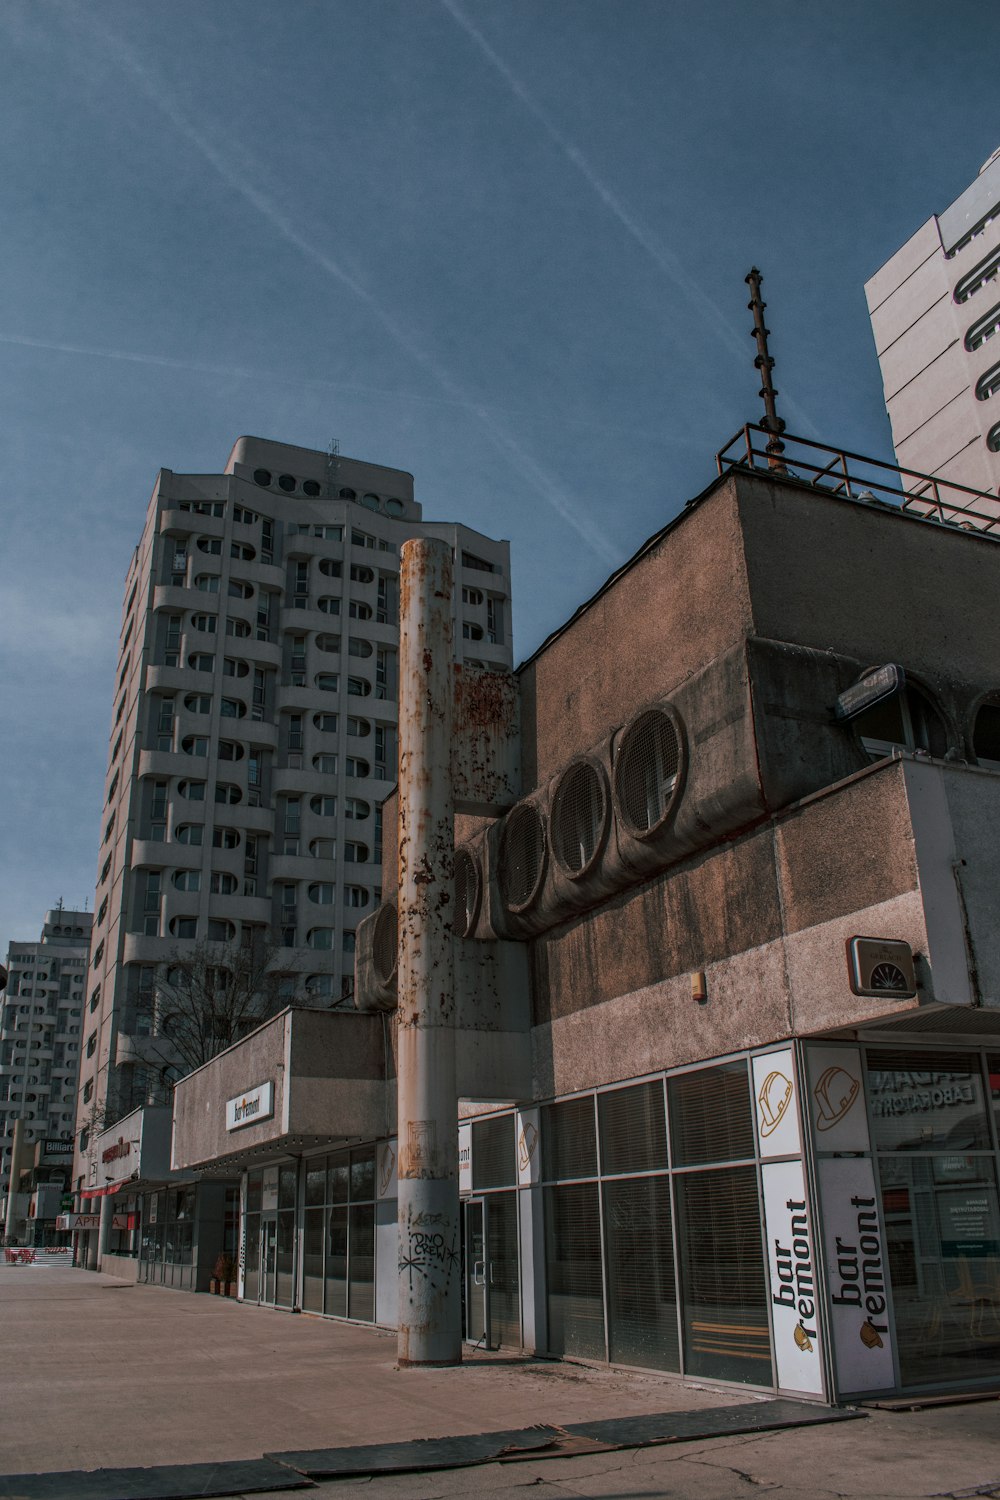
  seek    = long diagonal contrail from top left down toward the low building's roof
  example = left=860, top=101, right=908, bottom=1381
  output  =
left=60, top=11, right=621, bottom=564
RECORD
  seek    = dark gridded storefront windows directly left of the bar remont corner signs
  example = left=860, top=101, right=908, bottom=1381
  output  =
left=539, top=1059, right=772, bottom=1386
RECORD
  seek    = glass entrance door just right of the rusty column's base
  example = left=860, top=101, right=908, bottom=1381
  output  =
left=465, top=1193, right=522, bottom=1349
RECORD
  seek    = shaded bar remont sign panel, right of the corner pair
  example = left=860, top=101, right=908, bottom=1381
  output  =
left=817, top=1157, right=895, bottom=1395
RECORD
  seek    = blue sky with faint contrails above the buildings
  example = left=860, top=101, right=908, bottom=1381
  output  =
left=0, top=0, right=1000, bottom=947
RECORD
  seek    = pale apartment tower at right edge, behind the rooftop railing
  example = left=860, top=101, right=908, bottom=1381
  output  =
left=865, top=149, right=1000, bottom=525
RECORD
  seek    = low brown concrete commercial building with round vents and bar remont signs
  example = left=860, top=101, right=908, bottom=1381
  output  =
left=172, top=447, right=1000, bottom=1401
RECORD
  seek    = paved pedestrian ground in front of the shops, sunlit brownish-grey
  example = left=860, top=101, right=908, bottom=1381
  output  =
left=0, top=1263, right=1000, bottom=1500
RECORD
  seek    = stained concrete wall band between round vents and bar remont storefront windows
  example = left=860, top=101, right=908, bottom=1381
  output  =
left=531, top=762, right=934, bottom=1097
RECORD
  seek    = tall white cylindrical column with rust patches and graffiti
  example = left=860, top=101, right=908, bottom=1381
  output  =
left=397, top=537, right=462, bottom=1365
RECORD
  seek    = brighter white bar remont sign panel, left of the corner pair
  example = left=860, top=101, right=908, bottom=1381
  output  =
left=754, top=1158, right=823, bottom=1397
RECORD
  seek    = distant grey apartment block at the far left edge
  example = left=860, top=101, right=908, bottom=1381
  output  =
left=0, top=908, right=93, bottom=1233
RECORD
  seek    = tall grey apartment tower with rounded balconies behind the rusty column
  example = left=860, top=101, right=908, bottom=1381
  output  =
left=73, top=438, right=511, bottom=1196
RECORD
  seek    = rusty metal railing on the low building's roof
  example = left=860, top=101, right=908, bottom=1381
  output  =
left=715, top=422, right=1000, bottom=537
